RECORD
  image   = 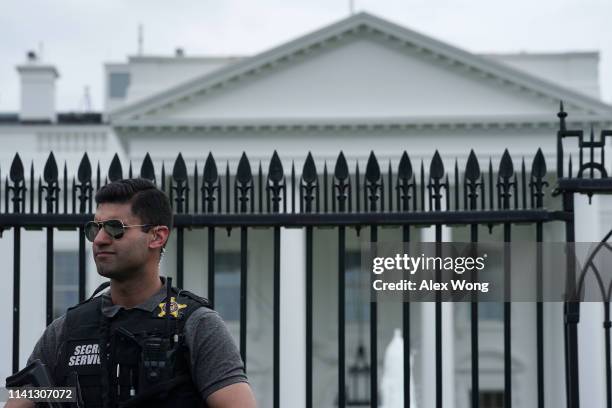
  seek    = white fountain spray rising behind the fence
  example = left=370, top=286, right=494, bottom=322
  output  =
left=381, top=329, right=417, bottom=408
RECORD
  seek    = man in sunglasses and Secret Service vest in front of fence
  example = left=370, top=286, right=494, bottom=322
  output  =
left=7, top=179, right=256, bottom=408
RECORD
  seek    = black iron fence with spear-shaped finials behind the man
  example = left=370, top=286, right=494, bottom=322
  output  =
left=0, top=106, right=612, bottom=408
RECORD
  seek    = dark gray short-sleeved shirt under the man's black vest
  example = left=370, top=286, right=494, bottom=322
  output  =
left=28, top=288, right=247, bottom=400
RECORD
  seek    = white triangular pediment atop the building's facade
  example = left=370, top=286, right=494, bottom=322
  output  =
left=111, top=13, right=612, bottom=124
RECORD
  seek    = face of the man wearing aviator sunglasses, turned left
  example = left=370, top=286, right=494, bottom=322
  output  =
left=93, top=203, right=156, bottom=281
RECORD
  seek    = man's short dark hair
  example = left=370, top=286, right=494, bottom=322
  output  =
left=96, top=179, right=173, bottom=230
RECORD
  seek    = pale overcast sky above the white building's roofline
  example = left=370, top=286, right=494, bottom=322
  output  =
left=0, top=0, right=612, bottom=112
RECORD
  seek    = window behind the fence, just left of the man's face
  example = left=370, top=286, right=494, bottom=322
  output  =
left=53, top=251, right=79, bottom=319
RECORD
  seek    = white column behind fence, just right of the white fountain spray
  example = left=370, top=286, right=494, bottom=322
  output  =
left=420, top=226, right=455, bottom=408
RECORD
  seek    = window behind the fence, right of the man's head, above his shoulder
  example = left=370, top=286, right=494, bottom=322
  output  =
left=215, top=251, right=240, bottom=321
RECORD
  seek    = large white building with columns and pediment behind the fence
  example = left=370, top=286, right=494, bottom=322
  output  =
left=0, top=13, right=612, bottom=408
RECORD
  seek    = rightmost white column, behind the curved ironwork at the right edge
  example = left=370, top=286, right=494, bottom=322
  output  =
left=574, top=194, right=609, bottom=408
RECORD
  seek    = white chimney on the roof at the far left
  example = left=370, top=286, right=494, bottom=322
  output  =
left=17, top=51, right=59, bottom=122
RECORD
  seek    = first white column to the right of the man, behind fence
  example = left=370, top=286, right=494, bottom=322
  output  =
left=280, top=181, right=306, bottom=408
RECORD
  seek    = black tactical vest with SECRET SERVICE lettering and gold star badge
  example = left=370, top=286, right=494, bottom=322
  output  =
left=54, top=288, right=209, bottom=408
